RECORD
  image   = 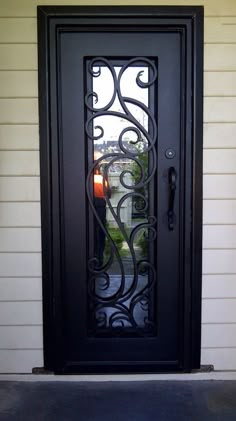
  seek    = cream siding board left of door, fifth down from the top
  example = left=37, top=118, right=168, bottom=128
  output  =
left=0, top=98, right=38, bottom=124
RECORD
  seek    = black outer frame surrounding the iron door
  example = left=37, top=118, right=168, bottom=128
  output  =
left=38, top=6, right=203, bottom=372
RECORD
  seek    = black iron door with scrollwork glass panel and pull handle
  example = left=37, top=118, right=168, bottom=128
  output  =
left=38, top=5, right=203, bottom=372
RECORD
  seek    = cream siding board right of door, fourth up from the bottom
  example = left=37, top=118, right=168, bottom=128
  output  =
left=202, top=274, right=236, bottom=298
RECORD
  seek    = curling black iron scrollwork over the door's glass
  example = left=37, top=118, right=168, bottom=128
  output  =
left=85, top=57, right=157, bottom=336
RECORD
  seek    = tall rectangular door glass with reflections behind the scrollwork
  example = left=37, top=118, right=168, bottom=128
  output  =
left=85, top=58, right=157, bottom=336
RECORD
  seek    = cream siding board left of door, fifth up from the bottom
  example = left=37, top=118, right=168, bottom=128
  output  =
left=0, top=253, right=42, bottom=277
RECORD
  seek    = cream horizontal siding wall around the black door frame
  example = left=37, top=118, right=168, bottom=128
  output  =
left=0, top=0, right=236, bottom=373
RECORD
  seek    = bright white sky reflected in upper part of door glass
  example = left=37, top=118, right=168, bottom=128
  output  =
left=93, top=66, right=148, bottom=144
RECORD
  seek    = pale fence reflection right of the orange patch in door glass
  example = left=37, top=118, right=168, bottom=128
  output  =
left=107, top=172, right=132, bottom=227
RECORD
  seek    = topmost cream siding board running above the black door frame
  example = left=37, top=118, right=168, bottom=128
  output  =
left=0, top=0, right=233, bottom=17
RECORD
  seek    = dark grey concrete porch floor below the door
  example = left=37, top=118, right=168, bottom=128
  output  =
left=0, top=380, right=236, bottom=421
